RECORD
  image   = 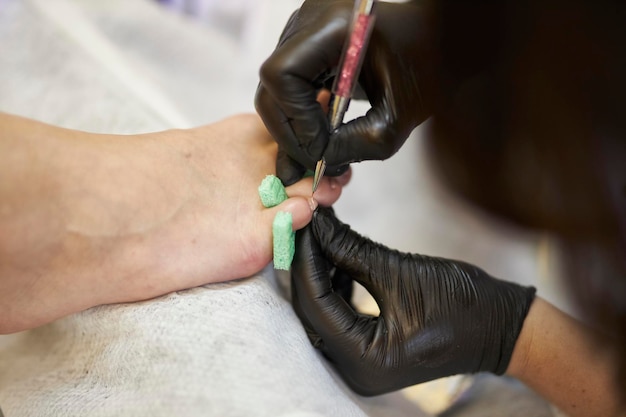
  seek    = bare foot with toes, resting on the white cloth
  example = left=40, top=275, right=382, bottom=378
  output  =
left=0, top=110, right=350, bottom=333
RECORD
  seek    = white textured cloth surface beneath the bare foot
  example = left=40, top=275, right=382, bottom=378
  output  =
left=0, top=268, right=420, bottom=417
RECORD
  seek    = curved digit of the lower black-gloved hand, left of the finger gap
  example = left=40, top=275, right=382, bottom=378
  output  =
left=291, top=226, right=358, bottom=344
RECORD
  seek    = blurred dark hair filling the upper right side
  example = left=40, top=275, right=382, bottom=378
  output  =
left=429, top=0, right=626, bottom=389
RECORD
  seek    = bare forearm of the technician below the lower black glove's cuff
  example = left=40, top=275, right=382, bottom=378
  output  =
left=507, top=298, right=626, bottom=417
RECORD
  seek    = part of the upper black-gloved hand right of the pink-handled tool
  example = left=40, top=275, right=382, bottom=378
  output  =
left=316, top=2, right=432, bottom=165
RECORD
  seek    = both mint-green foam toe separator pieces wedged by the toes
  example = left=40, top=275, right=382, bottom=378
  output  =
left=259, top=175, right=296, bottom=271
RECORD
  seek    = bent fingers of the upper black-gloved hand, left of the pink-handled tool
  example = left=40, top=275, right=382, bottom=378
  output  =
left=255, top=9, right=350, bottom=169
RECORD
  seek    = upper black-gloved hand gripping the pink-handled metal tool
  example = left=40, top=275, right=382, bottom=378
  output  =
left=255, top=0, right=432, bottom=185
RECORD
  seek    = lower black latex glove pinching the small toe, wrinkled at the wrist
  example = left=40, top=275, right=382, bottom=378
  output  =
left=292, top=208, right=535, bottom=395
